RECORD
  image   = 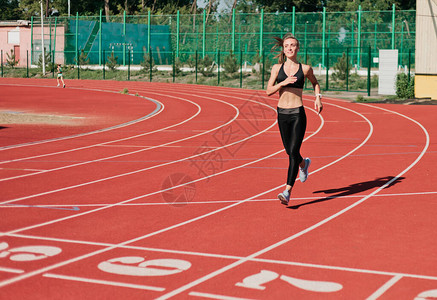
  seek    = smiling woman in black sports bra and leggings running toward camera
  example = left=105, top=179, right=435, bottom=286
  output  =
left=267, top=33, right=323, bottom=205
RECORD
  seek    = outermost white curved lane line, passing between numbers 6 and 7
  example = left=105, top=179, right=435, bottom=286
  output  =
left=156, top=101, right=429, bottom=300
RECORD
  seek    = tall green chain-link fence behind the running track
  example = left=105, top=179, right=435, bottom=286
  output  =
left=1, top=6, right=416, bottom=91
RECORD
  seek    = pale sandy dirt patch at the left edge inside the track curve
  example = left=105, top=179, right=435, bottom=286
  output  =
left=0, top=110, right=84, bottom=126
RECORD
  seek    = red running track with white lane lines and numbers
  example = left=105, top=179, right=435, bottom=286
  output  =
left=0, top=79, right=437, bottom=299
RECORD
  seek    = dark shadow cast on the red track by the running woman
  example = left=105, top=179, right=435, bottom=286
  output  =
left=288, top=176, right=405, bottom=209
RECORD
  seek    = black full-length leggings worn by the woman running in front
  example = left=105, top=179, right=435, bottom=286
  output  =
left=278, top=106, right=307, bottom=187
